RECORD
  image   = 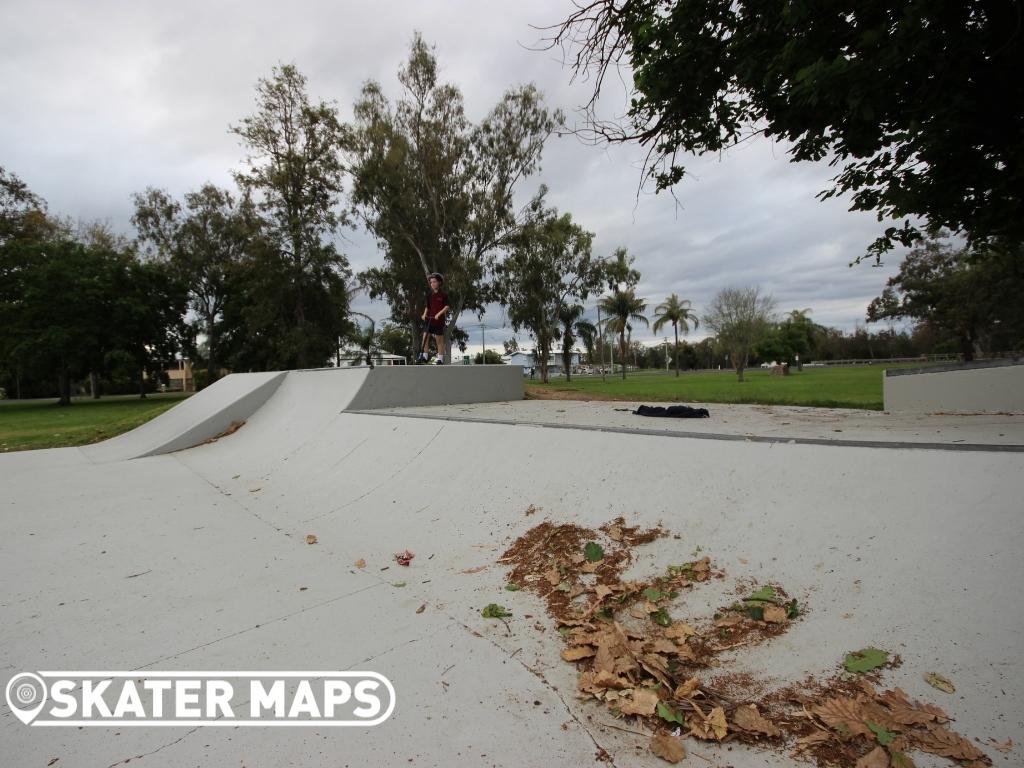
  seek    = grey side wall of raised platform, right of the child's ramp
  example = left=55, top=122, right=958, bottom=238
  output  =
left=346, top=366, right=524, bottom=411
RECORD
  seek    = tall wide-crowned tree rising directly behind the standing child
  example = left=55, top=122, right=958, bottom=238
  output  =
left=347, top=35, right=562, bottom=364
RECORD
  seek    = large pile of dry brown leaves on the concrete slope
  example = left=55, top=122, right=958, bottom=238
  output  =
left=500, top=518, right=991, bottom=768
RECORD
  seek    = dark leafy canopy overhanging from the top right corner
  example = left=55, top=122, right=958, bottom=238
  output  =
left=550, top=0, right=1024, bottom=260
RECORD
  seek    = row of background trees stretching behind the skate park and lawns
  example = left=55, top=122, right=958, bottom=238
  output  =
left=0, top=28, right=1024, bottom=403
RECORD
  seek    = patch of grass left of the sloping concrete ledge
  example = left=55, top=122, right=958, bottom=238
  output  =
left=0, top=392, right=189, bottom=452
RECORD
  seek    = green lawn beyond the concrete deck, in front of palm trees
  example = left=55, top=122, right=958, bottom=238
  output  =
left=526, top=365, right=929, bottom=411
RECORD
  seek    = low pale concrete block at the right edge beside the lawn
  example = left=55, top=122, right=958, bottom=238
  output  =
left=883, top=364, right=1024, bottom=414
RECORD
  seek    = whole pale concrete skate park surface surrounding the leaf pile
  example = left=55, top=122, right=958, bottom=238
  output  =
left=0, top=366, right=1024, bottom=768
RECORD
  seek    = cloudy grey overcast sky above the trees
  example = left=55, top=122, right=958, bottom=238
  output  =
left=0, top=0, right=913, bottom=352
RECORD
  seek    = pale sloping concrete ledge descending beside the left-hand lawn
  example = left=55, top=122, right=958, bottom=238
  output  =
left=80, top=371, right=287, bottom=463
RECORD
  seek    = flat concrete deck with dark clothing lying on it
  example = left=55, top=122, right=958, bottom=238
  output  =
left=368, top=400, right=1024, bottom=450
